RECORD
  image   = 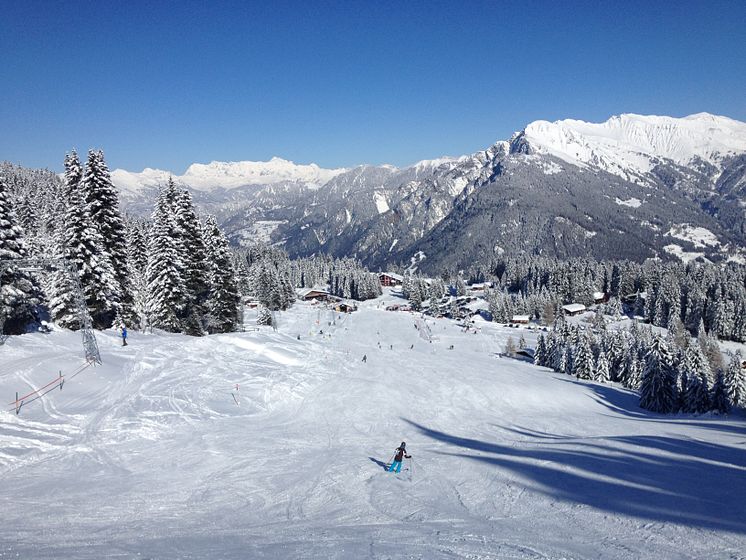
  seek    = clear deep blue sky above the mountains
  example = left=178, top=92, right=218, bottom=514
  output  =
left=0, top=0, right=746, bottom=173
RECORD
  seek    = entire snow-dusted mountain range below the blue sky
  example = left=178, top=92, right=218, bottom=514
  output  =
left=112, top=113, right=746, bottom=271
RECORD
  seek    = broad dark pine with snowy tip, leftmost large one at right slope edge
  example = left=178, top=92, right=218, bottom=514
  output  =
left=640, top=335, right=677, bottom=414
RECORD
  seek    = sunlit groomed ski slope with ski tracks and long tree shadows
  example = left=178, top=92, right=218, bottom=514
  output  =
left=0, top=296, right=746, bottom=559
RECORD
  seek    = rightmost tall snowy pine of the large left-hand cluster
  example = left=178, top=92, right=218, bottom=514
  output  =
left=203, top=216, right=238, bottom=333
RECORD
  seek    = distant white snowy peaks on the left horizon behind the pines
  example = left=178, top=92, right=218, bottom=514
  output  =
left=111, top=157, right=346, bottom=192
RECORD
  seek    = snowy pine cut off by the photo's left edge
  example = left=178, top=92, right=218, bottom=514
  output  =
left=0, top=177, right=38, bottom=334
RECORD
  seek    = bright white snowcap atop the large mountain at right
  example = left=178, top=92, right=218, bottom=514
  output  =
left=525, top=113, right=746, bottom=179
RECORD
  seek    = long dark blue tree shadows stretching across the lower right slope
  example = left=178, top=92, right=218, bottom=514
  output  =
left=404, top=419, right=746, bottom=534
